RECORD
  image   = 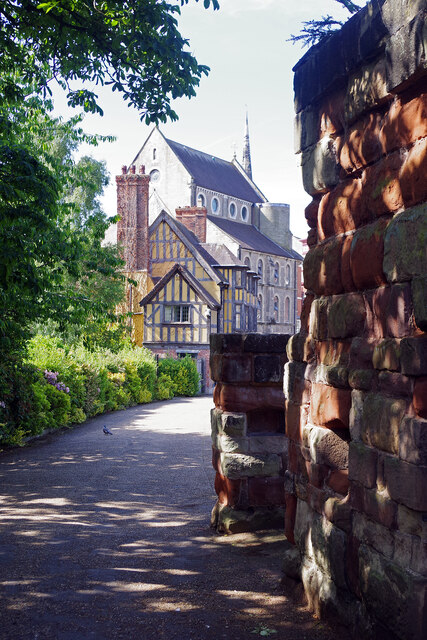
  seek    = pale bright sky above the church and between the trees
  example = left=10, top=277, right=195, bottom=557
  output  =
left=51, top=0, right=361, bottom=238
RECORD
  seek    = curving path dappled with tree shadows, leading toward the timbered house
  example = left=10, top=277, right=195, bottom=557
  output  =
left=0, top=397, right=345, bottom=640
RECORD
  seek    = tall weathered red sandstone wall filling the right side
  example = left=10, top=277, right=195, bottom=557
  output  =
left=284, top=0, right=427, bottom=639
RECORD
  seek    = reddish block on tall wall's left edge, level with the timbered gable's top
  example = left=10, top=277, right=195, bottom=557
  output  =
left=303, top=237, right=344, bottom=296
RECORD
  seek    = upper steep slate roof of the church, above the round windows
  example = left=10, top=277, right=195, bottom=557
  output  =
left=166, top=139, right=265, bottom=202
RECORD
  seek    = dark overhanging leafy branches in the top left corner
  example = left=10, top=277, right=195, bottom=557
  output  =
left=0, top=0, right=219, bottom=124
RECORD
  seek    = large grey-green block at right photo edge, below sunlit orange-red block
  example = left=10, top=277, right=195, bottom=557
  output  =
left=383, top=203, right=427, bottom=282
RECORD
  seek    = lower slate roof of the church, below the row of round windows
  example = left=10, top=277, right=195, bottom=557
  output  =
left=208, top=216, right=302, bottom=260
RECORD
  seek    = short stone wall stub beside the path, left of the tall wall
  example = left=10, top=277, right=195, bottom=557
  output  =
left=210, top=334, right=288, bottom=533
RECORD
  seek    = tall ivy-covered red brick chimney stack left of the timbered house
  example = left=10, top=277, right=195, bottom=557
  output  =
left=116, top=165, right=150, bottom=272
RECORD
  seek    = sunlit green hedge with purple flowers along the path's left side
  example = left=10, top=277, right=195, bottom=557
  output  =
left=0, top=335, right=199, bottom=445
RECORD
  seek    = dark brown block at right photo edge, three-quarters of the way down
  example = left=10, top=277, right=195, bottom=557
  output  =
left=384, top=456, right=427, bottom=511
